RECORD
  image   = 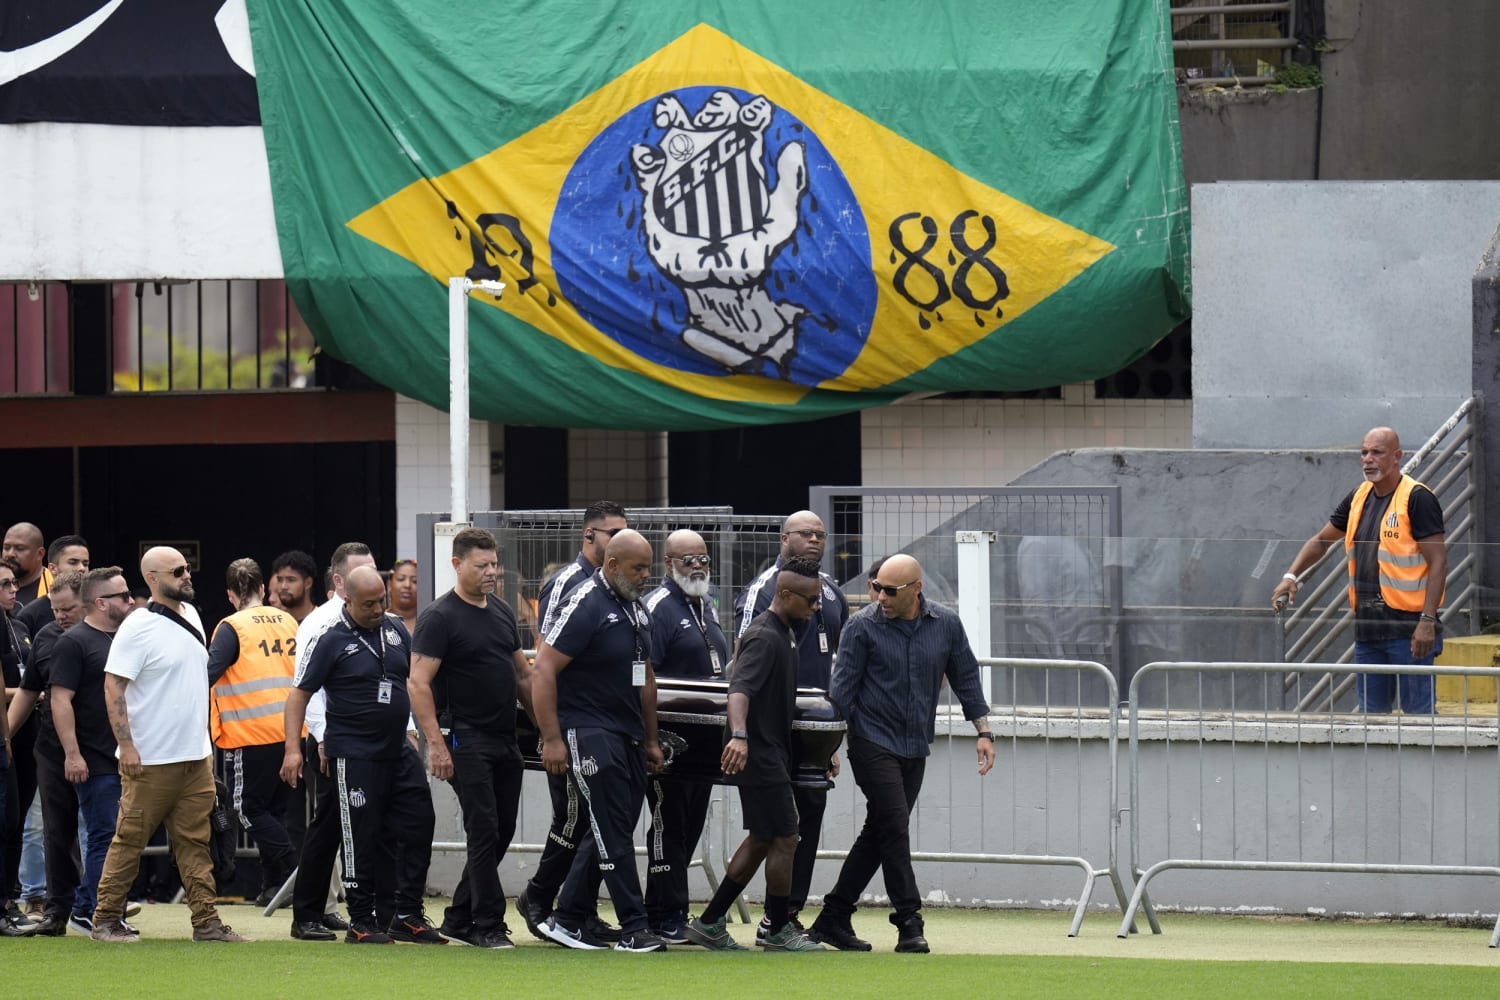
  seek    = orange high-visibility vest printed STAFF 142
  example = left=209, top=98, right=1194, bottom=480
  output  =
left=209, top=607, right=297, bottom=750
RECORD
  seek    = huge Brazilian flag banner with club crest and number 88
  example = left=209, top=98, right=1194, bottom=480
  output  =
left=248, top=0, right=1188, bottom=430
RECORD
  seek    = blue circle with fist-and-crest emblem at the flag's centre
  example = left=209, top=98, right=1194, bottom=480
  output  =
left=549, top=85, right=876, bottom=385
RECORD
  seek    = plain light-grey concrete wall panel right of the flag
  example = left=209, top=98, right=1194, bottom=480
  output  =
left=1193, top=181, right=1500, bottom=448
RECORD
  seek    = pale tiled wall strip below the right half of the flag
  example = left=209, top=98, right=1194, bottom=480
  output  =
left=860, top=382, right=1193, bottom=486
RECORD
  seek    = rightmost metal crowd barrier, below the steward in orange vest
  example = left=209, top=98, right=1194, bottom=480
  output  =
left=1119, top=663, right=1500, bottom=948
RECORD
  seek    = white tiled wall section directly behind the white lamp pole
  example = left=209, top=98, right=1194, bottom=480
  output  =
left=383, top=396, right=498, bottom=558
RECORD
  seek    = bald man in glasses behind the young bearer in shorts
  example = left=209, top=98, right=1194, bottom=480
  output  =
left=735, top=510, right=849, bottom=945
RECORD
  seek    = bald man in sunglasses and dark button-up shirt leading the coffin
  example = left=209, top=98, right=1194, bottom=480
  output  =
left=812, top=555, right=995, bottom=952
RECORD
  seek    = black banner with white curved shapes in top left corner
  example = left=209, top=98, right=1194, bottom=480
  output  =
left=0, top=0, right=261, bottom=126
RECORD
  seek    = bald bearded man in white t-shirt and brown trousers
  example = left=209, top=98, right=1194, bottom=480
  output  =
left=93, top=546, right=248, bottom=943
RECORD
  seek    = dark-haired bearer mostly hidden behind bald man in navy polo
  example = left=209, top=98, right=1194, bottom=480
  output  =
left=516, top=501, right=627, bottom=942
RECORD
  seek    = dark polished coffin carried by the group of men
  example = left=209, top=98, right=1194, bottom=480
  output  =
left=516, top=678, right=846, bottom=789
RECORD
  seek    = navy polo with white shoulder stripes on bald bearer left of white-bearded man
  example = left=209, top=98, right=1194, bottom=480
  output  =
left=543, top=571, right=651, bottom=739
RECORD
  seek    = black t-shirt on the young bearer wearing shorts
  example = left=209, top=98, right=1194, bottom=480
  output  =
left=729, top=612, right=798, bottom=786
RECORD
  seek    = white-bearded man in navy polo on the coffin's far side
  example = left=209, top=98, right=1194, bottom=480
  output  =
left=645, top=528, right=729, bottom=945
